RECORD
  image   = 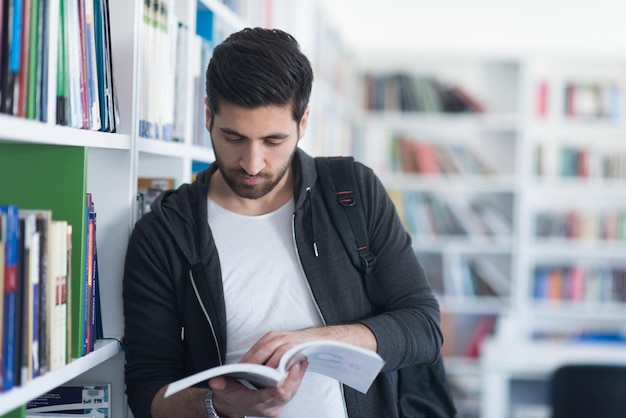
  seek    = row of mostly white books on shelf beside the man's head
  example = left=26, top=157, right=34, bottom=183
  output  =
left=138, top=0, right=217, bottom=147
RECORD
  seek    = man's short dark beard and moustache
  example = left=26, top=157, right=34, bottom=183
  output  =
left=214, top=148, right=296, bottom=199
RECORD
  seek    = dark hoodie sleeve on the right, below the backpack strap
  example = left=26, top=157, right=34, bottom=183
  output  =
left=357, top=164, right=443, bottom=370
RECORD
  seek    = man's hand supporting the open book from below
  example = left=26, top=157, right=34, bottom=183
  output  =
left=209, top=361, right=307, bottom=418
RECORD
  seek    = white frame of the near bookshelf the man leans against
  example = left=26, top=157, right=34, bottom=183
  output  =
left=0, top=0, right=354, bottom=418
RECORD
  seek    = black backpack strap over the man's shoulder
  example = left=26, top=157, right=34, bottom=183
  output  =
left=315, top=157, right=385, bottom=311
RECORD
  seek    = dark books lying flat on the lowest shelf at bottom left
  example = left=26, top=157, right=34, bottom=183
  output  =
left=26, top=383, right=111, bottom=418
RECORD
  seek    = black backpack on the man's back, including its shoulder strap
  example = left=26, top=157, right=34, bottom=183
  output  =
left=315, top=157, right=458, bottom=418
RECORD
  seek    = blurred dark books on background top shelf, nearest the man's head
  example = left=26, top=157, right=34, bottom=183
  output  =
left=363, top=73, right=485, bottom=113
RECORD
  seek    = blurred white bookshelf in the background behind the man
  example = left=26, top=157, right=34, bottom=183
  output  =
left=348, top=53, right=626, bottom=417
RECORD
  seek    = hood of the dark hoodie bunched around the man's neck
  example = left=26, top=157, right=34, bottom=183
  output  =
left=146, top=148, right=317, bottom=265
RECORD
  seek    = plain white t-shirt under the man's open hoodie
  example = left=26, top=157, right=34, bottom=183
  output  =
left=208, top=199, right=347, bottom=418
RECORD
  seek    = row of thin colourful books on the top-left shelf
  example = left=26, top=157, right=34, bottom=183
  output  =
left=0, top=0, right=119, bottom=132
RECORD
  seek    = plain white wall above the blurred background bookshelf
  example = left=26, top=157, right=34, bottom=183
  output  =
left=322, top=0, right=626, bottom=55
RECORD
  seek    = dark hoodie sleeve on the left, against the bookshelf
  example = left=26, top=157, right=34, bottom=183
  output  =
left=123, top=213, right=185, bottom=417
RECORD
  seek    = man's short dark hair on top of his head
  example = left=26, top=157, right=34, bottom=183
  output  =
left=206, top=28, right=313, bottom=127
